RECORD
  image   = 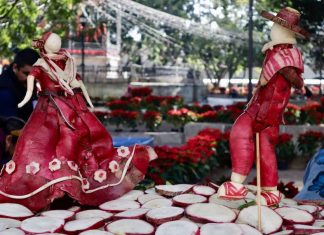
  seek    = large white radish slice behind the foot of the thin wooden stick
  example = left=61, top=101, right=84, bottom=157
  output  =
left=236, top=206, right=283, bottom=234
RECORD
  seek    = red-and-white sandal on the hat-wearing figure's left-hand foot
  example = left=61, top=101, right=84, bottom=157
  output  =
left=217, top=181, right=248, bottom=200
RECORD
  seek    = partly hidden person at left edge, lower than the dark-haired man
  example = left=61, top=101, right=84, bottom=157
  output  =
left=0, top=117, right=25, bottom=169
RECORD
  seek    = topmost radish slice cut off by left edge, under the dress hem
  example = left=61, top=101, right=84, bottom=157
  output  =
left=0, top=203, right=34, bottom=220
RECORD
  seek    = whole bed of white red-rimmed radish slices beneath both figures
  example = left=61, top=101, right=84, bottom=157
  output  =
left=0, top=184, right=324, bottom=235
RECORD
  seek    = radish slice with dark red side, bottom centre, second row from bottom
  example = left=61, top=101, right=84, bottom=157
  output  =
left=146, top=207, right=184, bottom=225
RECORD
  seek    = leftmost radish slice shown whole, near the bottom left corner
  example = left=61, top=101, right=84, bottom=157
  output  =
left=20, top=216, right=64, bottom=234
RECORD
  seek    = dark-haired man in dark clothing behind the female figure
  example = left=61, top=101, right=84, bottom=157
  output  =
left=0, top=48, right=39, bottom=121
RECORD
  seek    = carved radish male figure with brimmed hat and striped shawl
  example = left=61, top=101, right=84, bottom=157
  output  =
left=218, top=7, right=308, bottom=206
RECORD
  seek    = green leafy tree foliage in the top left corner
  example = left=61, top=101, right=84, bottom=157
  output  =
left=0, top=0, right=80, bottom=56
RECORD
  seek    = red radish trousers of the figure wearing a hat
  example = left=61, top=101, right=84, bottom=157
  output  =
left=230, top=112, right=279, bottom=187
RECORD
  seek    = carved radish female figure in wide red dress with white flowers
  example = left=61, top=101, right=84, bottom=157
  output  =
left=0, top=32, right=157, bottom=211
